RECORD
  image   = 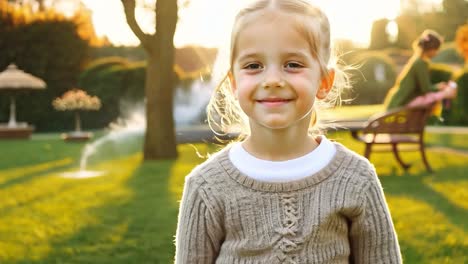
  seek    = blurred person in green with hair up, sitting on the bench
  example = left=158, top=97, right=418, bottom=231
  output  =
left=385, top=30, right=456, bottom=109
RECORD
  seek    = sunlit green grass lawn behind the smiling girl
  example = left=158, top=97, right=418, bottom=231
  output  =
left=0, top=132, right=468, bottom=264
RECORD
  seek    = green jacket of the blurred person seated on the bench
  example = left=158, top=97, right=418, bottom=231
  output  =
left=385, top=57, right=437, bottom=109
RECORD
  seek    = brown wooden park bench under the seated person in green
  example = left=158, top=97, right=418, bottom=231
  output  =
left=341, top=105, right=433, bottom=172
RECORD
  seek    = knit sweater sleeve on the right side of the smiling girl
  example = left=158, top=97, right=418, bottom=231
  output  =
left=350, top=171, right=402, bottom=264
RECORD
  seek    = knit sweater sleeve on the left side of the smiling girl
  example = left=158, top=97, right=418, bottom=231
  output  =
left=175, top=175, right=223, bottom=264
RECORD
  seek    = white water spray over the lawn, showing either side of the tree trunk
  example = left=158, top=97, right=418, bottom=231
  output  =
left=62, top=80, right=212, bottom=179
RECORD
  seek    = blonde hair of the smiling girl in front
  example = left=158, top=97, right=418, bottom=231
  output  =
left=207, top=0, right=350, bottom=138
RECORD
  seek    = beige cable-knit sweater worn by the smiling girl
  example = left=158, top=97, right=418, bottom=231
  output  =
left=175, top=143, right=401, bottom=264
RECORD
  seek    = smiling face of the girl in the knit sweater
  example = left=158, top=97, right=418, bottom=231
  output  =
left=231, top=11, right=328, bottom=132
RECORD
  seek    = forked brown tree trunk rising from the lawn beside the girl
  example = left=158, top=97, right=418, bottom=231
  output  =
left=121, top=0, right=178, bottom=160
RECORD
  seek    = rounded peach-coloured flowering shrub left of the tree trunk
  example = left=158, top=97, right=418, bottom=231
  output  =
left=52, top=89, right=101, bottom=111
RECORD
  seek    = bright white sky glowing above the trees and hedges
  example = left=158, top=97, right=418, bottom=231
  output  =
left=82, top=0, right=441, bottom=47
